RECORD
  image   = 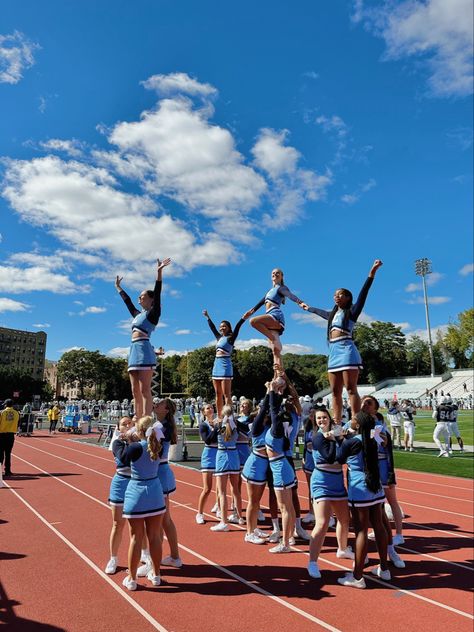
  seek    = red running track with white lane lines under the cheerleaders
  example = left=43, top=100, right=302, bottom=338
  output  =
left=0, top=433, right=474, bottom=632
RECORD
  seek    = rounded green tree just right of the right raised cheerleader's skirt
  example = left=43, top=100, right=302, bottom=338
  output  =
left=354, top=321, right=407, bottom=384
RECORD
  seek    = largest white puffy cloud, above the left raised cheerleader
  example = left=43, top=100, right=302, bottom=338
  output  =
left=2, top=73, right=331, bottom=294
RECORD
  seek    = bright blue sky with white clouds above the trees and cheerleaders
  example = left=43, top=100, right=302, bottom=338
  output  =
left=0, top=0, right=473, bottom=360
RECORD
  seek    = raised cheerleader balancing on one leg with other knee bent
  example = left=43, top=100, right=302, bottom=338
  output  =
left=242, top=268, right=308, bottom=370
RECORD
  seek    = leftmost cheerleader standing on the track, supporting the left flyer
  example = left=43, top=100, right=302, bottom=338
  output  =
left=105, top=417, right=132, bottom=575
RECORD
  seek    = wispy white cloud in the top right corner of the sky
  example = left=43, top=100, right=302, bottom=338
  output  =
left=353, top=0, right=473, bottom=97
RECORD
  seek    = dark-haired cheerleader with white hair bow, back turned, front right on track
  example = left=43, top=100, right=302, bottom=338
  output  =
left=336, top=411, right=391, bottom=588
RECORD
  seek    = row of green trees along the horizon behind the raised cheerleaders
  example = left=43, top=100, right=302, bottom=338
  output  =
left=45, top=309, right=474, bottom=399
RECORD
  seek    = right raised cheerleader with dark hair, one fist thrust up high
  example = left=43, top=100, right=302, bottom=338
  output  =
left=300, top=259, right=382, bottom=423
